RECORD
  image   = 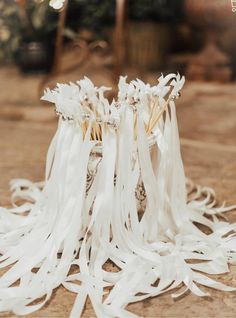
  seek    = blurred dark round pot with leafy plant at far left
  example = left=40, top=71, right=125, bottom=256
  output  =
left=1, top=0, right=58, bottom=73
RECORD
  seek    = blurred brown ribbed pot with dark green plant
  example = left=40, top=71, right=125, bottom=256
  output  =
left=127, top=0, right=182, bottom=69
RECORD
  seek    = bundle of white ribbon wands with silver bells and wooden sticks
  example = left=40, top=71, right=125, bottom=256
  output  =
left=0, top=74, right=236, bottom=317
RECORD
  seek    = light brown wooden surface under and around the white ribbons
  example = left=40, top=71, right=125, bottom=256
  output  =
left=0, top=76, right=236, bottom=318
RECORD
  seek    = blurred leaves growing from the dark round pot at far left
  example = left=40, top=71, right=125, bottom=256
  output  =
left=0, top=0, right=58, bottom=61
